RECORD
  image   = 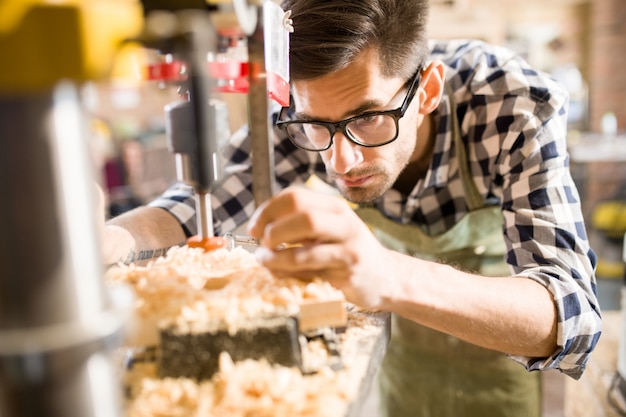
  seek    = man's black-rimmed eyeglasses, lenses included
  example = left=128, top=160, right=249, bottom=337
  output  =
left=276, top=66, right=422, bottom=152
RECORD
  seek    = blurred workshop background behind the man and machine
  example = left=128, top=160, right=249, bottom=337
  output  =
left=84, top=0, right=626, bottom=417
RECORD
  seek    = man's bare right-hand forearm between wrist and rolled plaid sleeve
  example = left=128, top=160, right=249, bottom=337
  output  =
left=383, top=252, right=557, bottom=357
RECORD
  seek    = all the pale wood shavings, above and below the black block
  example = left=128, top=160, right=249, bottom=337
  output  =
left=106, top=247, right=390, bottom=417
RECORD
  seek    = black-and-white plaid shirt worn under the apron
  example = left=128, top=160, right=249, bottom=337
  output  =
left=150, top=41, right=601, bottom=378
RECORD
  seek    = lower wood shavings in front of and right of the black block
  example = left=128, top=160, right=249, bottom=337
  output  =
left=124, top=313, right=381, bottom=417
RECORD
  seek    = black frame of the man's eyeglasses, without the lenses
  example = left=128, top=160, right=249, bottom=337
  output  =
left=276, top=65, right=422, bottom=152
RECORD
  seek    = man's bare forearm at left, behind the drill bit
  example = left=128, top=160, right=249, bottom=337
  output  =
left=102, top=207, right=185, bottom=265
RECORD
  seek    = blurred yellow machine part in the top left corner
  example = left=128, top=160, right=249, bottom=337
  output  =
left=0, top=0, right=143, bottom=92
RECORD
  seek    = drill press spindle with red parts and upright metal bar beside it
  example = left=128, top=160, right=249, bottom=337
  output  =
left=141, top=0, right=291, bottom=250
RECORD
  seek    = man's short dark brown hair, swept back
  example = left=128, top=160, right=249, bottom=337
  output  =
left=282, top=0, right=428, bottom=81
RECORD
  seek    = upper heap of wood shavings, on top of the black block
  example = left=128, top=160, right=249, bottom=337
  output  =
left=105, top=246, right=345, bottom=345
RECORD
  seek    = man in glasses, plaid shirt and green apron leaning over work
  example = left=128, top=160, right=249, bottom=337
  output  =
left=102, top=0, right=601, bottom=417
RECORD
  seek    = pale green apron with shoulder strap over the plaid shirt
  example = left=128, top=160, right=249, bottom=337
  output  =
left=356, top=90, right=541, bottom=417
